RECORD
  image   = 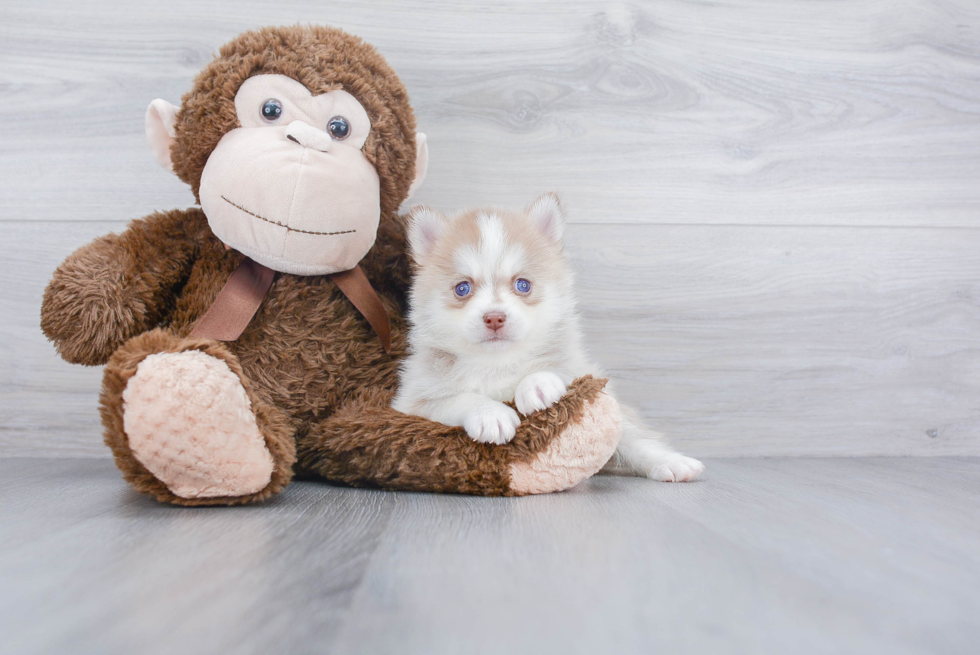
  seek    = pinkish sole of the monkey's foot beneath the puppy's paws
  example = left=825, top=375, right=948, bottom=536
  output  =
left=510, top=380, right=622, bottom=495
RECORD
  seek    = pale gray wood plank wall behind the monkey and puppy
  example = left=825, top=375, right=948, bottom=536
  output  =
left=0, top=0, right=980, bottom=456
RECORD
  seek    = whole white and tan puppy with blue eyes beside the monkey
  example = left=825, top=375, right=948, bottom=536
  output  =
left=392, top=193, right=704, bottom=482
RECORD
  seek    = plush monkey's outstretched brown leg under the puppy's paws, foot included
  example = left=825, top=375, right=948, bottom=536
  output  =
left=296, top=377, right=621, bottom=496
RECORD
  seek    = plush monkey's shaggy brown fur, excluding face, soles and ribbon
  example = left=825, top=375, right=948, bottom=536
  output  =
left=41, top=27, right=620, bottom=505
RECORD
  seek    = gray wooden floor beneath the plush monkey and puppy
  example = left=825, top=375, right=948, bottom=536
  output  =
left=0, top=458, right=980, bottom=654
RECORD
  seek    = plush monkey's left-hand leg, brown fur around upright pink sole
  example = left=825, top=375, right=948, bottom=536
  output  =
left=100, top=330, right=296, bottom=505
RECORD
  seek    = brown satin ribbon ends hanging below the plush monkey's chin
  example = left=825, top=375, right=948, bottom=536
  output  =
left=191, top=257, right=391, bottom=354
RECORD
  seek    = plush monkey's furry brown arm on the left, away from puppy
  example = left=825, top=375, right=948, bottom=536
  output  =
left=41, top=210, right=207, bottom=366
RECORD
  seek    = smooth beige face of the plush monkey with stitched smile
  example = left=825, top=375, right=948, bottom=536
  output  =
left=194, top=75, right=381, bottom=275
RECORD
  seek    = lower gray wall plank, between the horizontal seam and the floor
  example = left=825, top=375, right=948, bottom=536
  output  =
left=0, top=222, right=980, bottom=456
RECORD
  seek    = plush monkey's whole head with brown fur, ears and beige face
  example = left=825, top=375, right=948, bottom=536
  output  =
left=146, top=26, right=428, bottom=275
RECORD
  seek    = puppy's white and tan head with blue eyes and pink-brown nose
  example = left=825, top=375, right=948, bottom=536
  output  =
left=408, top=193, right=574, bottom=354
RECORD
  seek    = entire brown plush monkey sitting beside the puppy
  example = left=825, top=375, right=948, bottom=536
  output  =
left=41, top=27, right=619, bottom=505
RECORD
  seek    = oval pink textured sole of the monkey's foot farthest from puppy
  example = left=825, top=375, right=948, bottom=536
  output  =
left=122, top=350, right=274, bottom=499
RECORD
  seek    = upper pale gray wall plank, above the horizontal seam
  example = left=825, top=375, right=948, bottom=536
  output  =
left=0, top=0, right=980, bottom=226
